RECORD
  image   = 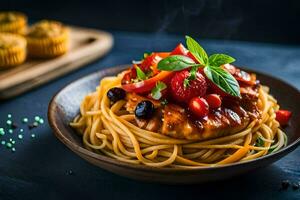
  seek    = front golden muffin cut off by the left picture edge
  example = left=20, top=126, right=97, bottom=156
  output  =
left=0, top=33, right=26, bottom=68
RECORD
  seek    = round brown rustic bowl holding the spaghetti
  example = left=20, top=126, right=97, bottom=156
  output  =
left=48, top=65, right=300, bottom=184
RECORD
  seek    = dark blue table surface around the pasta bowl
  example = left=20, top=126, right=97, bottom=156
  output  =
left=0, top=32, right=300, bottom=199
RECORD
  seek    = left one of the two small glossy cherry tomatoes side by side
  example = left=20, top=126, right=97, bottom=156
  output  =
left=189, top=97, right=209, bottom=118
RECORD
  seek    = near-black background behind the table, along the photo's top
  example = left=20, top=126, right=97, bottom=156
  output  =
left=0, top=0, right=300, bottom=44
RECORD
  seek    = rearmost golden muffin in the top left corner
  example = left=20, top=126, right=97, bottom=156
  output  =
left=0, top=12, right=27, bottom=35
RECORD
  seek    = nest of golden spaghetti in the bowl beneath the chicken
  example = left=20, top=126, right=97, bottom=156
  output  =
left=70, top=73, right=287, bottom=168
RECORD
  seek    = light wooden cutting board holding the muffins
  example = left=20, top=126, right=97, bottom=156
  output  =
left=0, top=27, right=113, bottom=99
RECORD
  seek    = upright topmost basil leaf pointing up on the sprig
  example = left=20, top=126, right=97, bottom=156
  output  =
left=185, top=36, right=208, bottom=65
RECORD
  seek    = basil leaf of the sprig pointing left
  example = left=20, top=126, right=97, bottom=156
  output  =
left=157, top=55, right=199, bottom=71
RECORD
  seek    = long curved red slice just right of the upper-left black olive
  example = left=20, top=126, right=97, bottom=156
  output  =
left=122, top=71, right=173, bottom=93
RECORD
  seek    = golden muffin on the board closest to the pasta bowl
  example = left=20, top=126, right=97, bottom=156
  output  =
left=26, top=20, right=69, bottom=58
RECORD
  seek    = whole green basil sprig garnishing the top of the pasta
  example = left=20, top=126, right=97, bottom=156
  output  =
left=158, top=36, right=241, bottom=97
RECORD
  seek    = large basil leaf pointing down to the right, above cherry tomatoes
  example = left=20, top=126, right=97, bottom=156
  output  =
left=204, top=66, right=241, bottom=97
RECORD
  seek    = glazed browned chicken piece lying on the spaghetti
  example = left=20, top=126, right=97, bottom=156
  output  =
left=125, top=88, right=260, bottom=140
